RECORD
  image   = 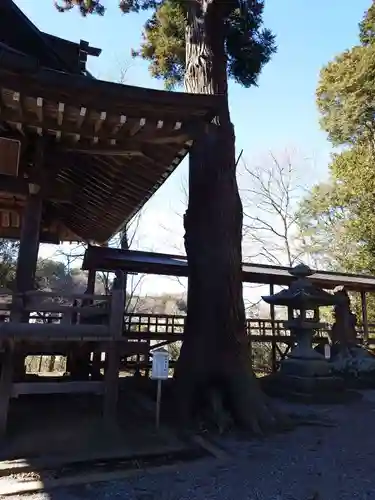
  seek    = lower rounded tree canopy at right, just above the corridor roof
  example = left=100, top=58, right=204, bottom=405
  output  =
left=298, top=155, right=375, bottom=274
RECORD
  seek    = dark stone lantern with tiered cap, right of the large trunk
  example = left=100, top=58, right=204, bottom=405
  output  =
left=262, top=264, right=342, bottom=392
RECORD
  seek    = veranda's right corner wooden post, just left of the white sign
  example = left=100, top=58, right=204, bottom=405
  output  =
left=104, top=286, right=124, bottom=423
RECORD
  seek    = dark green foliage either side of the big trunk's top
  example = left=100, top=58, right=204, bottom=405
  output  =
left=55, top=0, right=276, bottom=88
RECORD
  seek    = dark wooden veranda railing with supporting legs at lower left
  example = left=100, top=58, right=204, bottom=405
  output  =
left=0, top=290, right=128, bottom=434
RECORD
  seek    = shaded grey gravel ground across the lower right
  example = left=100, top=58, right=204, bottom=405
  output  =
left=6, top=391, right=375, bottom=500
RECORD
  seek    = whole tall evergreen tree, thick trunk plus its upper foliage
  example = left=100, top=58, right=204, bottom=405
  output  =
left=57, top=0, right=275, bottom=431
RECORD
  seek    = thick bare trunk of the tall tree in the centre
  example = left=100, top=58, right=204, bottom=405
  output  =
left=175, top=2, right=280, bottom=431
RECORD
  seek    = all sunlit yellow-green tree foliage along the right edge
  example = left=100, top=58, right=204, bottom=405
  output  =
left=300, top=2, right=375, bottom=280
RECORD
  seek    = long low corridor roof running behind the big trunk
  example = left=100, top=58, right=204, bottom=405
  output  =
left=82, top=246, right=375, bottom=292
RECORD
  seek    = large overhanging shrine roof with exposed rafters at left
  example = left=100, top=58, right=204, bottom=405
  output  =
left=0, top=45, right=221, bottom=243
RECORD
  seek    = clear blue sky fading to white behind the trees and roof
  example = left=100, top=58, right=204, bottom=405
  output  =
left=16, top=0, right=370, bottom=294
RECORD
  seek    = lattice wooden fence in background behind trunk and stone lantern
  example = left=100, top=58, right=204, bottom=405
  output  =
left=3, top=306, right=375, bottom=372
